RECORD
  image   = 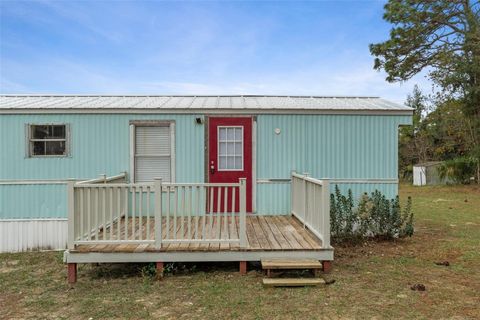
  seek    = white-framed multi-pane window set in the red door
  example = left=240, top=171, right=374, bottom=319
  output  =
left=217, top=126, right=243, bottom=171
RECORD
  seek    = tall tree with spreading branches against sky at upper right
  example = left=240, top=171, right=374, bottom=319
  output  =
left=370, top=0, right=480, bottom=183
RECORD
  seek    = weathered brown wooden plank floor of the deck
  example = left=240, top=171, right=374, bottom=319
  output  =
left=70, top=215, right=322, bottom=254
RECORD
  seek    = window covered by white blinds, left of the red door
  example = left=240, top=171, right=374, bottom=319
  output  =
left=135, top=126, right=172, bottom=182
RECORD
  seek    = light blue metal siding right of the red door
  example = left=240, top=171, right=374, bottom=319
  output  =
left=257, top=115, right=411, bottom=214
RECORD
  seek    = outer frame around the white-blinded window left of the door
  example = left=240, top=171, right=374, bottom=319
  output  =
left=130, top=120, right=176, bottom=183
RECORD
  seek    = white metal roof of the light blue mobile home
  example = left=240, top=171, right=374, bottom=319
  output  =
left=0, top=95, right=412, bottom=115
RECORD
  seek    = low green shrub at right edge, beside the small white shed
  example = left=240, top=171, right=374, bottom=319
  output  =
left=437, top=157, right=478, bottom=184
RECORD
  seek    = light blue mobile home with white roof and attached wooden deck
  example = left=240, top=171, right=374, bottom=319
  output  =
left=0, top=95, right=412, bottom=282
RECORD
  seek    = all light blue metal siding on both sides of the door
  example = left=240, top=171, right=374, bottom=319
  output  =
left=0, top=114, right=411, bottom=219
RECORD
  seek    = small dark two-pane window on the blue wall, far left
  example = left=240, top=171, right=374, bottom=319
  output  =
left=27, top=124, right=69, bottom=157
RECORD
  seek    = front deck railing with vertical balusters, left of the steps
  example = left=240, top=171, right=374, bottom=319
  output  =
left=68, top=178, right=247, bottom=249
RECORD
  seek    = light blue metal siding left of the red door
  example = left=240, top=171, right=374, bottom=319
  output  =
left=0, top=114, right=204, bottom=219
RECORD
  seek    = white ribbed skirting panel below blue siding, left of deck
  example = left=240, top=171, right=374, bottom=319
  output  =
left=0, top=219, right=67, bottom=252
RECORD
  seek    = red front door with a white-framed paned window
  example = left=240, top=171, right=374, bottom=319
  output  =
left=208, top=117, right=253, bottom=212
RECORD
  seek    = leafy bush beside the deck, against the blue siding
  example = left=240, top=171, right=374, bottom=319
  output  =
left=330, top=186, right=414, bottom=242
